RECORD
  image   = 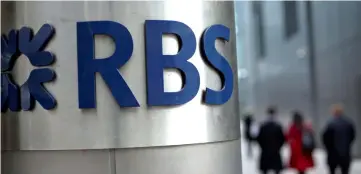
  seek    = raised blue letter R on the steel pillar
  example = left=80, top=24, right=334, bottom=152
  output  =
left=77, top=21, right=139, bottom=108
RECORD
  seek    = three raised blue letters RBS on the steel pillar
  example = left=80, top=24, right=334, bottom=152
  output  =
left=77, top=20, right=233, bottom=108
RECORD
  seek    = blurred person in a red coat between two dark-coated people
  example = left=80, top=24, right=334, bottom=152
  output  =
left=287, top=112, right=315, bottom=174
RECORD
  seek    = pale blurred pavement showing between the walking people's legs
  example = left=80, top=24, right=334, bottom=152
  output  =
left=242, top=126, right=361, bottom=174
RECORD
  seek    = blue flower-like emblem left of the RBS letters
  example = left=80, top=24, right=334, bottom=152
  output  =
left=1, top=24, right=56, bottom=112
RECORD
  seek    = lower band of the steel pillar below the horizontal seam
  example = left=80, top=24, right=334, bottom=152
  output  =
left=3, top=140, right=242, bottom=174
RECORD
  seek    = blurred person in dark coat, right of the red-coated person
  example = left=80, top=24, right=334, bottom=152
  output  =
left=322, top=105, right=356, bottom=174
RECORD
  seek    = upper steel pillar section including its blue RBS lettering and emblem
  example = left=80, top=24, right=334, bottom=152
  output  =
left=1, top=2, right=239, bottom=150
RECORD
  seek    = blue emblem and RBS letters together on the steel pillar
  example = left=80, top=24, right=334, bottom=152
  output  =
left=1, top=20, right=233, bottom=111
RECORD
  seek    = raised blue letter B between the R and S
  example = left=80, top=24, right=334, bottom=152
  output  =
left=145, top=20, right=200, bottom=106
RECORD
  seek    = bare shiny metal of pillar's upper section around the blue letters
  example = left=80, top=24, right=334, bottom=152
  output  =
left=2, top=1, right=239, bottom=150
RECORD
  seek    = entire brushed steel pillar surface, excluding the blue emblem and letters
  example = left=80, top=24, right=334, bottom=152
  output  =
left=1, top=0, right=242, bottom=174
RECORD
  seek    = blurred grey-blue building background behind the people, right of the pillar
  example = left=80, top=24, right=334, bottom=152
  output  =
left=235, top=1, right=361, bottom=174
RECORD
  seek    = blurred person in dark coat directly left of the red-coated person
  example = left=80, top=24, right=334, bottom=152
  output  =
left=257, top=107, right=285, bottom=174
